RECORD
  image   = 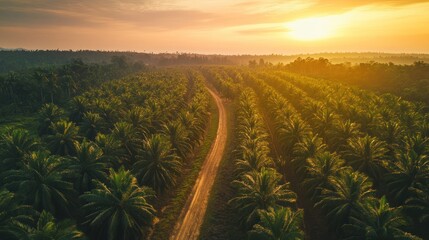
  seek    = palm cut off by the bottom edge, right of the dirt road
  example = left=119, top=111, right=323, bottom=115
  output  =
left=249, top=207, right=304, bottom=240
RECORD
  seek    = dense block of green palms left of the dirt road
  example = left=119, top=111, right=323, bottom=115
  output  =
left=0, top=70, right=209, bottom=239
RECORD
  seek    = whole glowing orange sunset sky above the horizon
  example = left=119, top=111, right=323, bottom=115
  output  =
left=0, top=0, right=429, bottom=54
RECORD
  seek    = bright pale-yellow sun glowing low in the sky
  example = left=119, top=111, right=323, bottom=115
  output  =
left=285, top=16, right=339, bottom=41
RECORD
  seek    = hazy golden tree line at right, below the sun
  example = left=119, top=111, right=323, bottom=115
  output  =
left=285, top=58, right=429, bottom=104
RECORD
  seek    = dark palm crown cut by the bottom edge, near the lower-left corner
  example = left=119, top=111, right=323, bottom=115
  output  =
left=24, top=211, right=87, bottom=240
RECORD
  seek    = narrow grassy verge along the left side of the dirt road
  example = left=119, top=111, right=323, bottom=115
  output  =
left=150, top=93, right=219, bottom=240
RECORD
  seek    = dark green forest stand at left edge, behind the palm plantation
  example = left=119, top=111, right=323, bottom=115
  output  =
left=0, top=56, right=145, bottom=113
